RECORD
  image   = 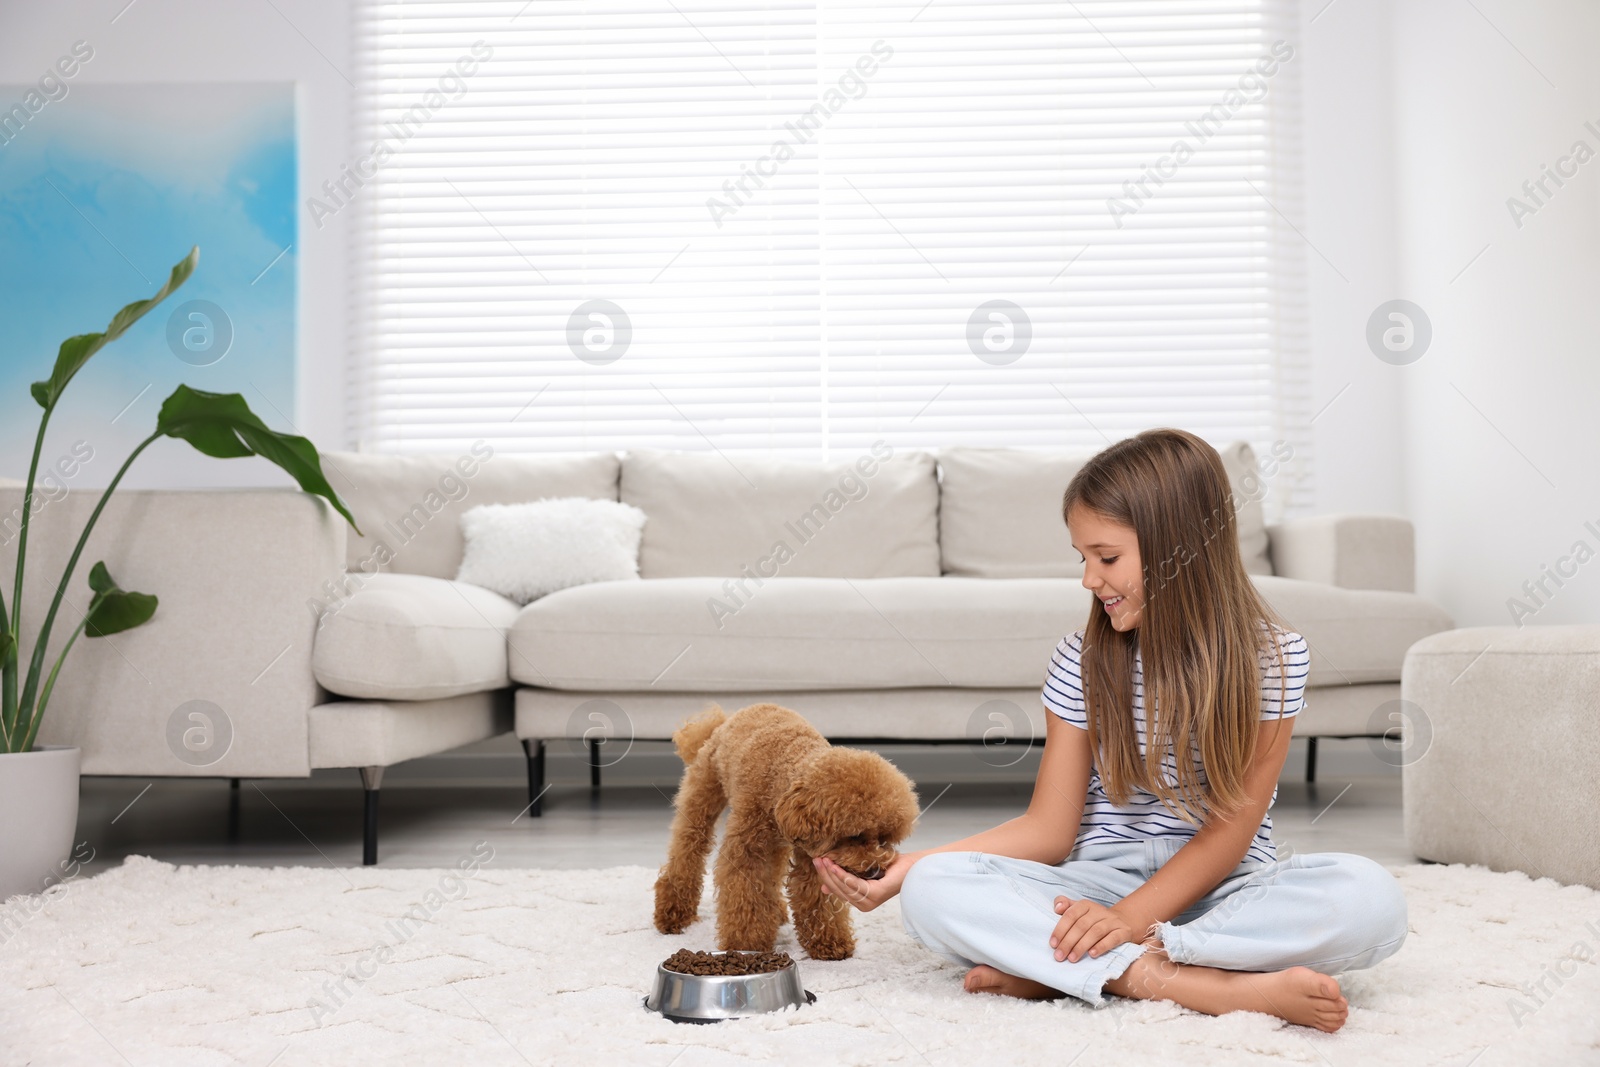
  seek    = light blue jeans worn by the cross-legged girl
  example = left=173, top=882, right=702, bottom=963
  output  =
left=901, top=838, right=1406, bottom=1006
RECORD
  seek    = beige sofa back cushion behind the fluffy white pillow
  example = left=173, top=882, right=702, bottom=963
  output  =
left=322, top=454, right=619, bottom=577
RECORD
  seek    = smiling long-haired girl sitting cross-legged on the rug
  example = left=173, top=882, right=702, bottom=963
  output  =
left=813, top=429, right=1406, bottom=1032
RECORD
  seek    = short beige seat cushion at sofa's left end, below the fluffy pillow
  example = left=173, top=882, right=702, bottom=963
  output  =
left=312, top=574, right=517, bottom=701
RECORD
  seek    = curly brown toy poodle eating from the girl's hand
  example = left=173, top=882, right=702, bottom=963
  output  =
left=656, top=704, right=917, bottom=960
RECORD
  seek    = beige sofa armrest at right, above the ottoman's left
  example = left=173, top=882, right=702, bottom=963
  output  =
left=1267, top=515, right=1416, bottom=593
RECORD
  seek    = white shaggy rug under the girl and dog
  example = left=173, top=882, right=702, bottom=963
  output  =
left=0, top=857, right=1600, bottom=1067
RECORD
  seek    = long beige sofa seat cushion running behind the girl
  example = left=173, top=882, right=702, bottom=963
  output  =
left=509, top=576, right=1450, bottom=693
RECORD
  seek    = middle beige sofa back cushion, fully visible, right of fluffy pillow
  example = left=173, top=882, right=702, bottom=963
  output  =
left=621, top=445, right=939, bottom=590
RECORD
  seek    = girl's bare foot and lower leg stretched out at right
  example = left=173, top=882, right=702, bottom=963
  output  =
left=1113, top=950, right=1350, bottom=1033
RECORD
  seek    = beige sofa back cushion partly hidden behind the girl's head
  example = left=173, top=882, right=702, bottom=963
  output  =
left=939, top=442, right=1272, bottom=577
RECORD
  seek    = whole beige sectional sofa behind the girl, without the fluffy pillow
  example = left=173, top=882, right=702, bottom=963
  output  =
left=0, top=443, right=1450, bottom=862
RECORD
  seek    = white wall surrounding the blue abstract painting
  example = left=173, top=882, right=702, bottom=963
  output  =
left=0, top=0, right=355, bottom=486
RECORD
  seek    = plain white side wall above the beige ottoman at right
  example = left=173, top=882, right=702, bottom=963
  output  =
left=1392, top=0, right=1600, bottom=625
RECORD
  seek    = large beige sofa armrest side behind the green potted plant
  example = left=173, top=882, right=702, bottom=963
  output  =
left=0, top=488, right=347, bottom=777
